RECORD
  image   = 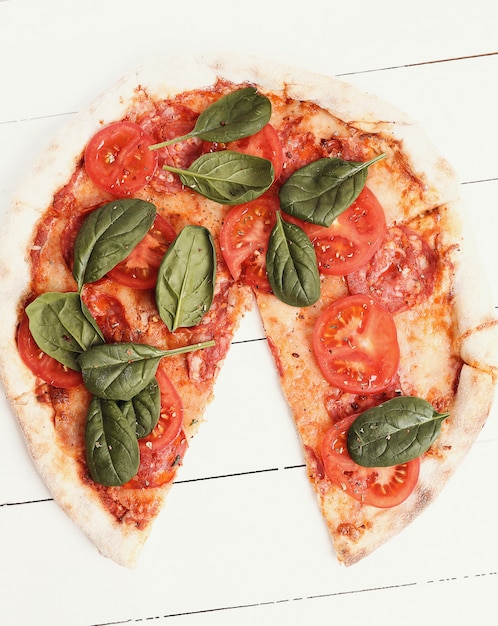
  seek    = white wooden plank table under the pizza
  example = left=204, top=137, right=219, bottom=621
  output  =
left=0, top=0, right=498, bottom=626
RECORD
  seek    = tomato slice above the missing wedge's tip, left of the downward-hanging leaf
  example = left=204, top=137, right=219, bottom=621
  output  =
left=220, top=194, right=280, bottom=293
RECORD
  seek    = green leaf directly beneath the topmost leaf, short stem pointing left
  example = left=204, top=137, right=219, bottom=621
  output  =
left=163, top=150, right=274, bottom=205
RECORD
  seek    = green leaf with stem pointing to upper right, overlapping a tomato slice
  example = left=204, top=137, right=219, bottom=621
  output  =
left=279, top=154, right=385, bottom=226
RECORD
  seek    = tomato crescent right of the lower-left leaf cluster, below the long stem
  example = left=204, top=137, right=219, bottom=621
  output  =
left=140, top=367, right=183, bottom=452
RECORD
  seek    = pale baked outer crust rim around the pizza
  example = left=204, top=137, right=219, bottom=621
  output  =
left=0, top=54, right=498, bottom=566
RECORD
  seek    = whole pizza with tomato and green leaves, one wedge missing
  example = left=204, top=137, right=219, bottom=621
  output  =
left=0, top=56, right=498, bottom=566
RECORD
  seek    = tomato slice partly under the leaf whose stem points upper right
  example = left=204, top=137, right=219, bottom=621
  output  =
left=284, top=187, right=387, bottom=276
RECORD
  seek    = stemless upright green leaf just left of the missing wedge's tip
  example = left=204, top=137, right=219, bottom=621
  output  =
left=156, top=226, right=216, bottom=331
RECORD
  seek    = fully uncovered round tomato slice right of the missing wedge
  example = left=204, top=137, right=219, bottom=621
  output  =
left=313, top=294, right=399, bottom=394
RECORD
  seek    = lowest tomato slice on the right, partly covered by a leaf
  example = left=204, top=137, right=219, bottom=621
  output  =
left=321, top=415, right=420, bottom=508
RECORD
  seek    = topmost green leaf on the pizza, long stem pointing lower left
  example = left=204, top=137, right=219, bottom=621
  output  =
left=150, top=87, right=271, bottom=150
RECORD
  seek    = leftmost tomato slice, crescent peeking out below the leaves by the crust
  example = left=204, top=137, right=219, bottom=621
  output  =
left=17, top=313, right=83, bottom=388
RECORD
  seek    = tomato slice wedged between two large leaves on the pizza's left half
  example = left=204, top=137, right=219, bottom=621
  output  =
left=107, top=214, right=176, bottom=289
